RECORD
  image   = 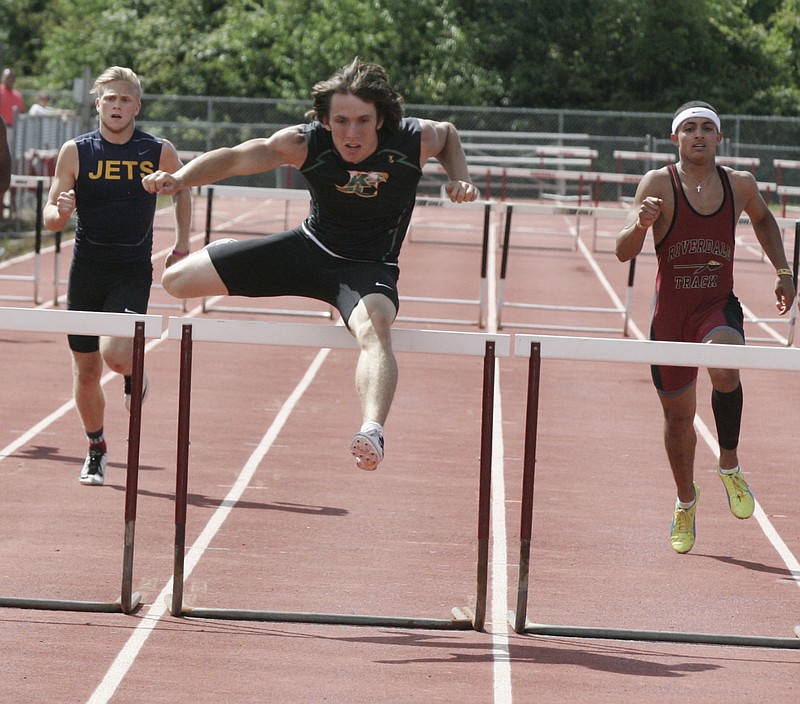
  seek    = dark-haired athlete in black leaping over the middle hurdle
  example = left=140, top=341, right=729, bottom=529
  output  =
left=143, top=59, right=478, bottom=470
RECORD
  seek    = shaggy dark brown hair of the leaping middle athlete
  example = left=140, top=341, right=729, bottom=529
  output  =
left=306, top=57, right=403, bottom=131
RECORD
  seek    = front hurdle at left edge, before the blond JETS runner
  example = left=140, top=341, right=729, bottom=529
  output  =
left=0, top=308, right=161, bottom=614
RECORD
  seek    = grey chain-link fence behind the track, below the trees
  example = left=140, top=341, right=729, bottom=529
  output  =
left=13, top=92, right=800, bottom=200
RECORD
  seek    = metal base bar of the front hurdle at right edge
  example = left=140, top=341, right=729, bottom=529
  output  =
left=508, top=611, right=800, bottom=650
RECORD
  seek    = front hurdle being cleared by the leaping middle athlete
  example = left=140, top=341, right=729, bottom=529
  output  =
left=168, top=318, right=510, bottom=631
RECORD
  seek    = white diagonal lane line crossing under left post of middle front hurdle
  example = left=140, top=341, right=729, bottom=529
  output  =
left=87, top=349, right=330, bottom=704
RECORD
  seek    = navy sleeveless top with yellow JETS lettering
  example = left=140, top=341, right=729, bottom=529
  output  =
left=74, top=128, right=163, bottom=263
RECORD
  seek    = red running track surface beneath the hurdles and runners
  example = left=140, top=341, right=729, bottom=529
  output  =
left=0, top=190, right=800, bottom=704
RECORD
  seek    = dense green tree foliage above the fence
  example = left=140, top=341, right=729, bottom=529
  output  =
left=0, top=0, right=800, bottom=116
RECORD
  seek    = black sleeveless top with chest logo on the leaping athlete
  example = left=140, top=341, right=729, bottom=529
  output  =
left=300, top=117, right=422, bottom=263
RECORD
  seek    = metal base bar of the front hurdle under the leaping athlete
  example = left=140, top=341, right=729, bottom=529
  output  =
left=178, top=606, right=476, bottom=628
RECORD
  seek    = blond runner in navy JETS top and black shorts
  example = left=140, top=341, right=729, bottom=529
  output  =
left=44, top=66, right=191, bottom=484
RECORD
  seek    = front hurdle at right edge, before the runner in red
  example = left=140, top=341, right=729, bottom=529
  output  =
left=508, top=335, right=800, bottom=649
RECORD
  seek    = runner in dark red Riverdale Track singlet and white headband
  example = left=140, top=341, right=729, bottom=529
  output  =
left=616, top=101, right=795, bottom=553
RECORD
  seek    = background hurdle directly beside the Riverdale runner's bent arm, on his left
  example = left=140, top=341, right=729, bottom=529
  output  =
left=497, top=203, right=636, bottom=337
